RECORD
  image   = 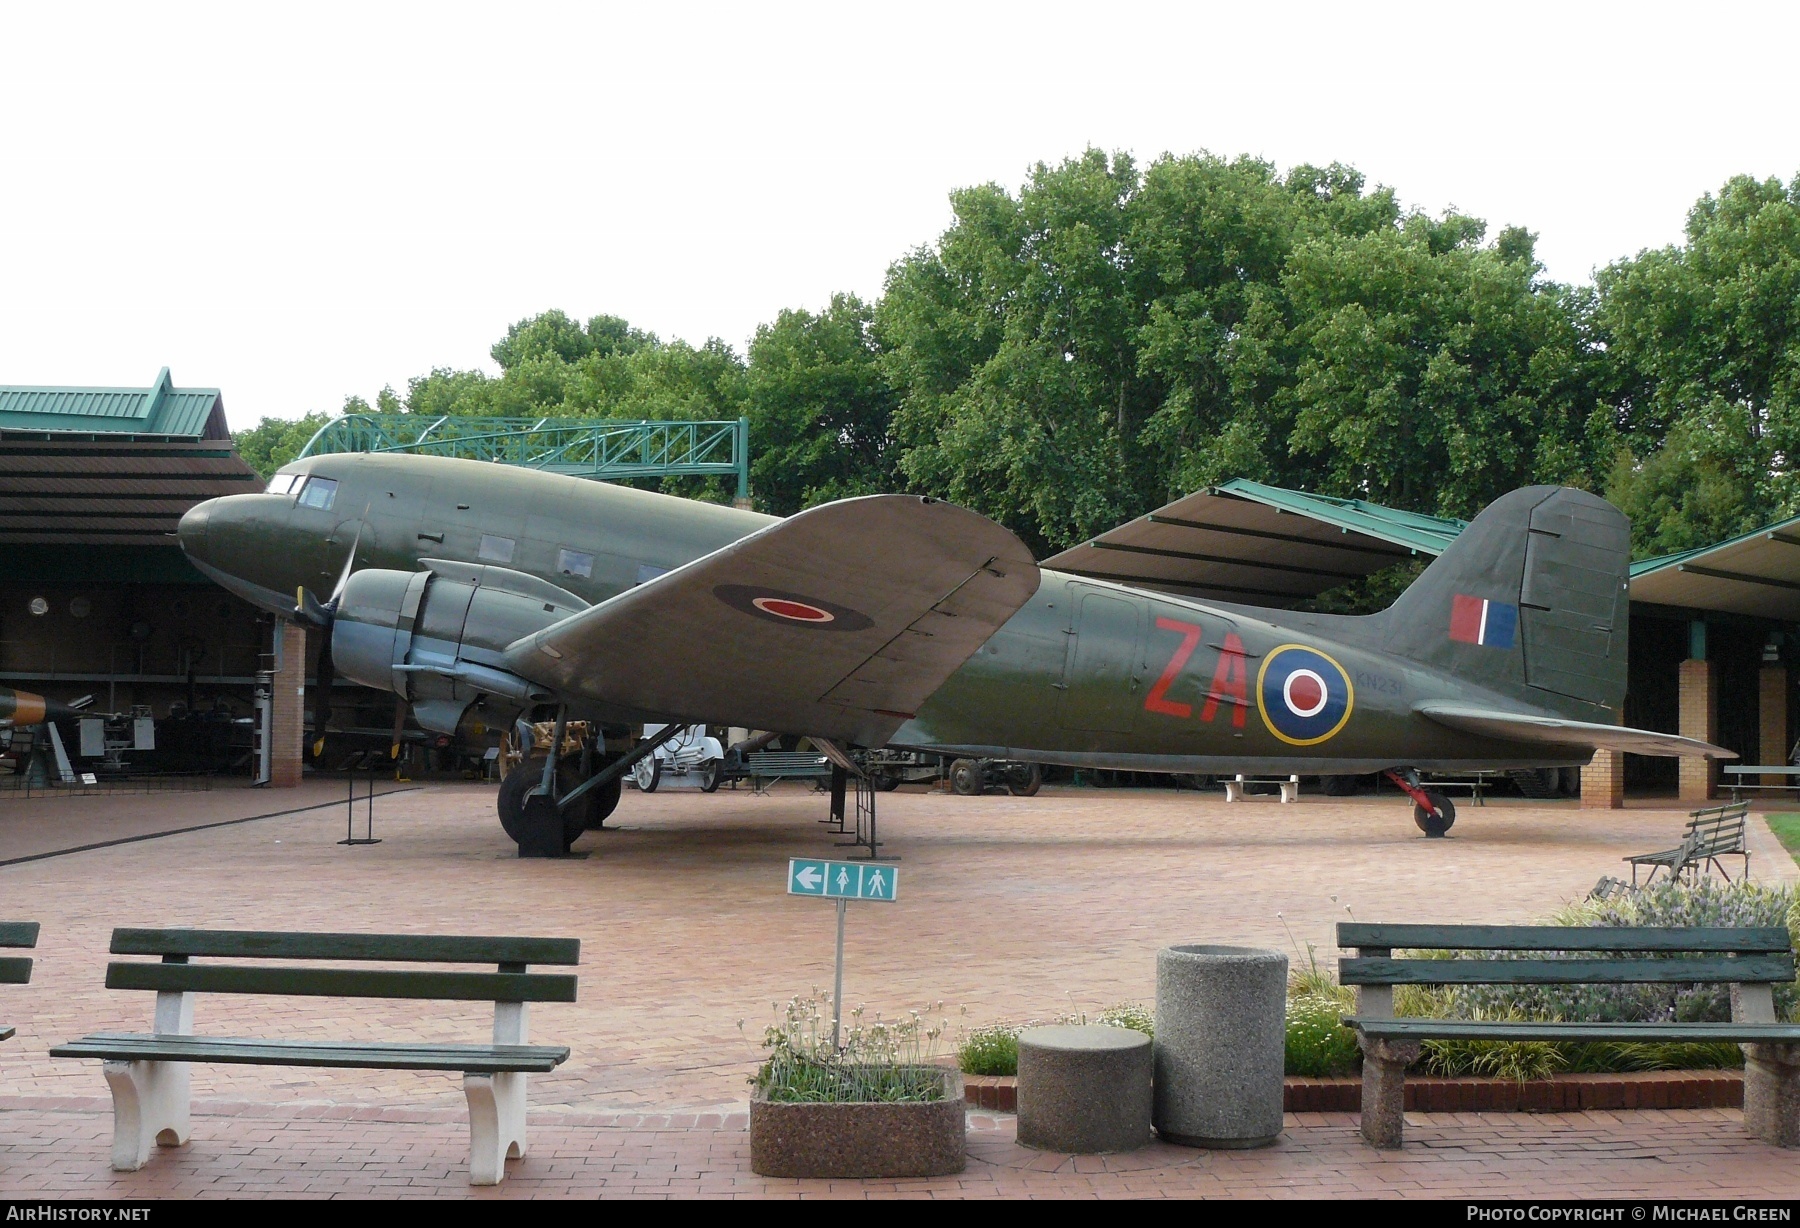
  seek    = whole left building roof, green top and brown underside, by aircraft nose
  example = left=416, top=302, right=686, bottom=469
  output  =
left=0, top=367, right=263, bottom=551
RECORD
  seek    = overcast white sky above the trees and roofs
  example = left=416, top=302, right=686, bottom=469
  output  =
left=0, top=0, right=1800, bottom=427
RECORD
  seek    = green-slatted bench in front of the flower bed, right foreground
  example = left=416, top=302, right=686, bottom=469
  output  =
left=1337, top=922, right=1800, bottom=1147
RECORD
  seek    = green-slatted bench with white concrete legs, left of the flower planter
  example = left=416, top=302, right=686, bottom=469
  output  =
left=50, top=929, right=581, bottom=1185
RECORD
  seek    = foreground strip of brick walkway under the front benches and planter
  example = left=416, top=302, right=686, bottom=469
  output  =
left=0, top=1104, right=1800, bottom=1199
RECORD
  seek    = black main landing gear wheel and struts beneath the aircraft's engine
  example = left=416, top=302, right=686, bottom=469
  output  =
left=497, top=713, right=688, bottom=857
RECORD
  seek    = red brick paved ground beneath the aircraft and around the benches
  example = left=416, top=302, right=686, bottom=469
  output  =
left=0, top=781, right=1793, bottom=1194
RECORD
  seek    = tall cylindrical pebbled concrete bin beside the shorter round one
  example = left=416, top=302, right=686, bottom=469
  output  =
left=1159, top=944, right=1287, bottom=1147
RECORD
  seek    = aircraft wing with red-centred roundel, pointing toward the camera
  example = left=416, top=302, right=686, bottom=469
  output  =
left=506, top=495, right=1039, bottom=745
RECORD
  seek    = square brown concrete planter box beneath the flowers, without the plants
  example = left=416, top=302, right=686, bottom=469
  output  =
left=751, top=1070, right=968, bottom=1178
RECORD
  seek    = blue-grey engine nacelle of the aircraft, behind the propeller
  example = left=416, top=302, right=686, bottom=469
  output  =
left=331, top=558, right=587, bottom=733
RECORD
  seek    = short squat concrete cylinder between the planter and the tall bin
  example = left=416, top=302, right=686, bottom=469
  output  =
left=1019, top=1025, right=1154, bottom=1156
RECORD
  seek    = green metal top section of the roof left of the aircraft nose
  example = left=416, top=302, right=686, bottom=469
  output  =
left=0, top=367, right=230, bottom=439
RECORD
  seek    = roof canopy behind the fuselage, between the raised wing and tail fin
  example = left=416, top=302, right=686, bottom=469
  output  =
left=1042, top=477, right=1467, bottom=607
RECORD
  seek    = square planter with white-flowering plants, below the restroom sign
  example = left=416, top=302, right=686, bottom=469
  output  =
left=751, top=992, right=967, bottom=1178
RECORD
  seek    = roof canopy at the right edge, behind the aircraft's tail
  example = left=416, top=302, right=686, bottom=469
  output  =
left=1631, top=517, right=1800, bottom=623
